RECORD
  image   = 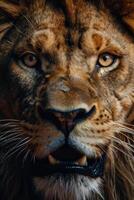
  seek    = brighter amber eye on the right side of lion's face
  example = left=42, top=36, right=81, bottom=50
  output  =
left=97, top=53, right=116, bottom=67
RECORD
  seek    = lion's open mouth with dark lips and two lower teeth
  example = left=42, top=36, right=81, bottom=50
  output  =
left=30, top=145, right=106, bottom=178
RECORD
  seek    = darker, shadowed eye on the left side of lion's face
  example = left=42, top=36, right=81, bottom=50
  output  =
left=20, top=53, right=39, bottom=68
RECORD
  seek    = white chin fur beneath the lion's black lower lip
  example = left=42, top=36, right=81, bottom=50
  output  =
left=34, top=174, right=103, bottom=200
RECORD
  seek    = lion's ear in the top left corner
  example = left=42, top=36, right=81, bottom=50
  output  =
left=0, top=0, right=22, bottom=39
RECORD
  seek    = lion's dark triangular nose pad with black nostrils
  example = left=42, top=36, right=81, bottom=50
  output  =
left=41, top=106, right=96, bottom=137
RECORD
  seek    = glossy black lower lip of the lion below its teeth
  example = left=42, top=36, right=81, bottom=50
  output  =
left=28, top=155, right=106, bottom=178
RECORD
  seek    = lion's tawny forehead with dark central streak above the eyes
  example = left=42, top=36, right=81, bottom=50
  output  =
left=25, top=1, right=128, bottom=65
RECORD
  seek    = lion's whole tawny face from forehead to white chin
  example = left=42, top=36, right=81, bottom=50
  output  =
left=1, top=1, right=134, bottom=200
